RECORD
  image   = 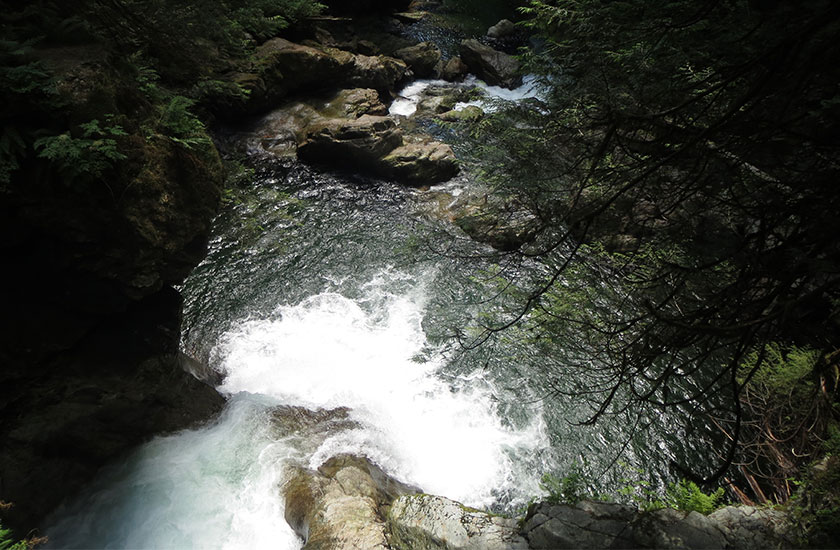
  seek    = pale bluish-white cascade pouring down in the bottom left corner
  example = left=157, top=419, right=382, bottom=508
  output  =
left=47, top=394, right=302, bottom=550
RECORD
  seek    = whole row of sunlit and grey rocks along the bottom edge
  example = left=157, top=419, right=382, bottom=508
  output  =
left=281, top=455, right=797, bottom=550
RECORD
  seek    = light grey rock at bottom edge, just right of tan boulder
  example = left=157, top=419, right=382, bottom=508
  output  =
left=388, top=495, right=528, bottom=550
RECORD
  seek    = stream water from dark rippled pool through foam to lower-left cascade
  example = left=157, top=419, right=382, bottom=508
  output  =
left=42, top=80, right=700, bottom=549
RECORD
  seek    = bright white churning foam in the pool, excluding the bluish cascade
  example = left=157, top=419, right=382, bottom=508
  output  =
left=216, top=272, right=548, bottom=506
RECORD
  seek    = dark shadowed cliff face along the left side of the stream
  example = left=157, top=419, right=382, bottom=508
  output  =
left=0, top=52, right=222, bottom=528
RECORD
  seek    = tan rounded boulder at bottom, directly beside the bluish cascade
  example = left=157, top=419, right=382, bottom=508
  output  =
left=282, top=455, right=418, bottom=550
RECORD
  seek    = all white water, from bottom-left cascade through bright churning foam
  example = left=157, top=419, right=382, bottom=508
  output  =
left=47, top=270, right=548, bottom=550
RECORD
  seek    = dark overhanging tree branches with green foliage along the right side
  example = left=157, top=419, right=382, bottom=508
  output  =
left=460, top=0, right=840, bottom=492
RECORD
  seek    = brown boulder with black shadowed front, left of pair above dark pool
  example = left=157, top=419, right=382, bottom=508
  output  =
left=298, top=115, right=403, bottom=169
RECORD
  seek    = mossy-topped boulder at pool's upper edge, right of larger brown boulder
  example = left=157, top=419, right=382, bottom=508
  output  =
left=382, top=140, right=459, bottom=186
